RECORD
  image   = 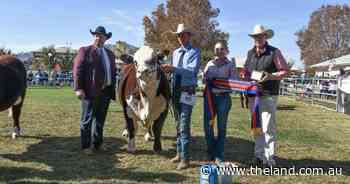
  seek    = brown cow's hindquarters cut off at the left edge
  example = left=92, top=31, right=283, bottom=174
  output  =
left=0, top=55, right=27, bottom=138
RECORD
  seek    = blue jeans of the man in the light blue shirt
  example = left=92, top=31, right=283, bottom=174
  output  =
left=175, top=102, right=193, bottom=160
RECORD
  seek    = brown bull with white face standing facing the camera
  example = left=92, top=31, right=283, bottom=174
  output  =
left=118, top=46, right=171, bottom=152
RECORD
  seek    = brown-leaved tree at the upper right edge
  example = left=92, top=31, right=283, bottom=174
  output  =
left=296, top=5, right=350, bottom=66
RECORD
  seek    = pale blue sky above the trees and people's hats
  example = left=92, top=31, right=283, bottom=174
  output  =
left=0, top=0, right=350, bottom=65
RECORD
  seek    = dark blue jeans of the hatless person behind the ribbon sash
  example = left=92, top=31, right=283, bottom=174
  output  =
left=204, top=95, right=232, bottom=161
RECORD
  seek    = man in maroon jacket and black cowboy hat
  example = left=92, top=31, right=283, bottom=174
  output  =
left=73, top=26, right=116, bottom=154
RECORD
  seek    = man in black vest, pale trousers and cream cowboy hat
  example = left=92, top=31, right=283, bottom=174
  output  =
left=244, top=25, right=289, bottom=166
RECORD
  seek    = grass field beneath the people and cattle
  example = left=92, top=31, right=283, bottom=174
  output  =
left=0, top=89, right=350, bottom=183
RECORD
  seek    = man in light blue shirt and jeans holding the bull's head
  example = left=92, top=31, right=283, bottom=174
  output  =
left=161, top=24, right=200, bottom=169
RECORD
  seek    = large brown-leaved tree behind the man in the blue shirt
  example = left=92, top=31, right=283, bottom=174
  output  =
left=143, top=0, right=229, bottom=67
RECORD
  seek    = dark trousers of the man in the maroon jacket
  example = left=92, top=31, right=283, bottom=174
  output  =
left=80, top=90, right=110, bottom=149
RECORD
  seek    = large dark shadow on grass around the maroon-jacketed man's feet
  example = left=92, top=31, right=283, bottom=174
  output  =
left=0, top=136, right=186, bottom=183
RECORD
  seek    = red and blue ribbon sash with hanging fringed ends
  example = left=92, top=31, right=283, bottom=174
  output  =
left=203, top=79, right=262, bottom=136
